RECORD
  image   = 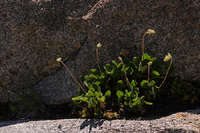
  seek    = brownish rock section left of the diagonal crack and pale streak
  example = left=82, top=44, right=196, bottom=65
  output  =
left=0, top=0, right=95, bottom=102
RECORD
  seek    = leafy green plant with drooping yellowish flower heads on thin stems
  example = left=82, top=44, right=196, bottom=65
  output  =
left=57, top=29, right=172, bottom=118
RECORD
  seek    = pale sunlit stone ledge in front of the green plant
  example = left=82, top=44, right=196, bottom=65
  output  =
left=0, top=110, right=200, bottom=133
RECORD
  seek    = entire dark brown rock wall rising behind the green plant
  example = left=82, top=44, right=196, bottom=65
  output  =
left=0, top=0, right=200, bottom=104
